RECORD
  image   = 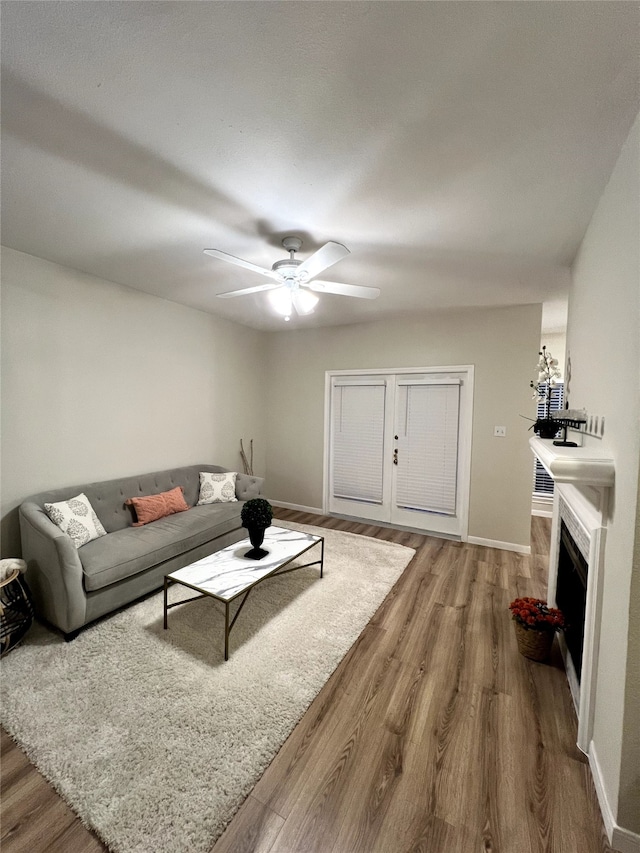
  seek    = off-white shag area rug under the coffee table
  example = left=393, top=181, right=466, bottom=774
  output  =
left=1, top=521, right=415, bottom=853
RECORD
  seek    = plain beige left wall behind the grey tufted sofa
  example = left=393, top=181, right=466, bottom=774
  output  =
left=1, top=248, right=265, bottom=556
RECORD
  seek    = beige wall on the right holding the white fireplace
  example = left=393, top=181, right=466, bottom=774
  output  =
left=567, top=111, right=640, bottom=832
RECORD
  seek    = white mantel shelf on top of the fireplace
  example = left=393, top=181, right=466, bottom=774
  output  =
left=529, top=437, right=615, bottom=489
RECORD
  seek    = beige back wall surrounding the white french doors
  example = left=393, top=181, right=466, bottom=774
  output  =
left=267, top=305, right=541, bottom=547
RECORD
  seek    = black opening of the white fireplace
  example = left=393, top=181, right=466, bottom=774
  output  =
left=556, top=521, right=589, bottom=684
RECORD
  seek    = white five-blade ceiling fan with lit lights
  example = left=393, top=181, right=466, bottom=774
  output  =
left=204, top=237, right=380, bottom=320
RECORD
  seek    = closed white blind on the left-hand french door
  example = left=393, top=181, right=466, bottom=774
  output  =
left=331, top=383, right=386, bottom=504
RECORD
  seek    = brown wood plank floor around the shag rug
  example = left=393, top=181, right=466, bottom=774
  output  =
left=0, top=509, right=610, bottom=853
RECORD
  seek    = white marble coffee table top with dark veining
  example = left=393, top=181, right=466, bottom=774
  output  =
left=167, top=526, right=322, bottom=601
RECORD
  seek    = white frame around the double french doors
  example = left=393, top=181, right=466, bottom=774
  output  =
left=322, top=364, right=474, bottom=542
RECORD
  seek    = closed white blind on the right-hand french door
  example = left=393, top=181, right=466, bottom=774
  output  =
left=396, top=383, right=460, bottom=515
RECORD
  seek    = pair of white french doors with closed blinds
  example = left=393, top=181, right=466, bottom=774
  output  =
left=325, top=367, right=473, bottom=538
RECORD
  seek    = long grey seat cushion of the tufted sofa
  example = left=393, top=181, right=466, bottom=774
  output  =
left=78, top=502, right=243, bottom=591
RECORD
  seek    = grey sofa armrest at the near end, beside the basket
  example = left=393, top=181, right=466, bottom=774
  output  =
left=19, top=502, right=87, bottom=634
